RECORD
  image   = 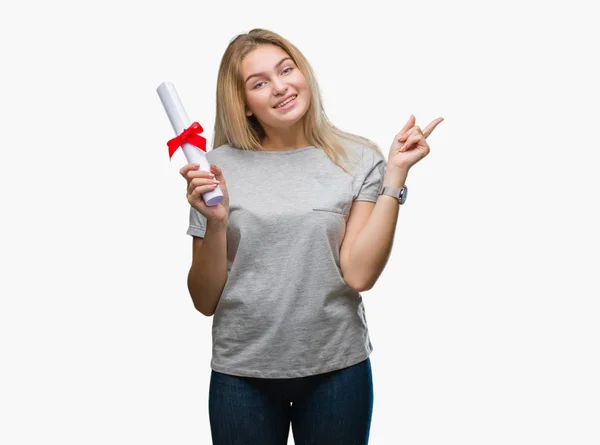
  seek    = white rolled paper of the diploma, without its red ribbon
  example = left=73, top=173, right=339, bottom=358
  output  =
left=156, top=82, right=223, bottom=206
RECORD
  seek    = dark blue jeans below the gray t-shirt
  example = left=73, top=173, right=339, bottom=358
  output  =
left=208, top=358, right=373, bottom=445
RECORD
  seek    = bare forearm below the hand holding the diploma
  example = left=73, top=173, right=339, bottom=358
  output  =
left=188, top=221, right=227, bottom=317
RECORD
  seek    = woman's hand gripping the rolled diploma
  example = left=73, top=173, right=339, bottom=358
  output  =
left=179, top=163, right=229, bottom=228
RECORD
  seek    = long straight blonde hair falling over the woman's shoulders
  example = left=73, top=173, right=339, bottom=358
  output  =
left=213, top=28, right=381, bottom=173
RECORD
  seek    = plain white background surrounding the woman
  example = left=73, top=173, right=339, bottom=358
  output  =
left=0, top=0, right=600, bottom=445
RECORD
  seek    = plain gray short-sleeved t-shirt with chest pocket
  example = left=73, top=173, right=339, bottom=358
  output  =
left=187, top=140, right=386, bottom=378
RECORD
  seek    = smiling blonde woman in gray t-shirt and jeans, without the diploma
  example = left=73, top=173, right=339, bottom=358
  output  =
left=181, top=29, right=441, bottom=445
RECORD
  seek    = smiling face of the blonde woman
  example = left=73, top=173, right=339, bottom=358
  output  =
left=242, top=45, right=310, bottom=128
